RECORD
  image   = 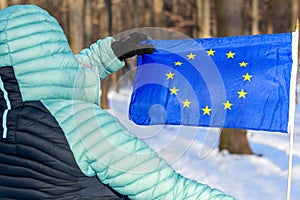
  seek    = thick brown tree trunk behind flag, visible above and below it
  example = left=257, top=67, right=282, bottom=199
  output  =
left=216, top=0, right=252, bottom=154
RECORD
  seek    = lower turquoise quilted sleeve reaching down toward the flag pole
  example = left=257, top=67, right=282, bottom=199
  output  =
left=43, top=101, right=235, bottom=200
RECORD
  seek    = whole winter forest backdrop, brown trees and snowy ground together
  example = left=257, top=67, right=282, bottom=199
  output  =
left=0, top=0, right=300, bottom=200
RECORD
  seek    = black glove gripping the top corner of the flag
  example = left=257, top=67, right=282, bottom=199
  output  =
left=111, top=33, right=154, bottom=60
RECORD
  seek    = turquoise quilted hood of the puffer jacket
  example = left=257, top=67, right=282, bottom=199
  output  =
left=0, top=5, right=99, bottom=104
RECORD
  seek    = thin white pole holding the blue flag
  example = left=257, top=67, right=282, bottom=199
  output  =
left=286, top=19, right=299, bottom=200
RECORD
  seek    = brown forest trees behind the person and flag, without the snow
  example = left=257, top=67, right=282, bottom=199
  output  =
left=0, top=0, right=300, bottom=154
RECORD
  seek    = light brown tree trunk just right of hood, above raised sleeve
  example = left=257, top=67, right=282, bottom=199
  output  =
left=69, top=0, right=84, bottom=53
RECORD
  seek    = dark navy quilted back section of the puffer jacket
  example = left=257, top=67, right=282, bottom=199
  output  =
left=0, top=67, right=122, bottom=200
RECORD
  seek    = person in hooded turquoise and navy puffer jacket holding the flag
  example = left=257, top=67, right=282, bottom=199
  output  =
left=0, top=5, right=235, bottom=200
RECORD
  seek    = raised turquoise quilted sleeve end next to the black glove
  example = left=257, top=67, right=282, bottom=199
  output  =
left=75, top=37, right=124, bottom=79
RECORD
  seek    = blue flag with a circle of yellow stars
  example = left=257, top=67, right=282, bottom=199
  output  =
left=129, top=33, right=293, bottom=132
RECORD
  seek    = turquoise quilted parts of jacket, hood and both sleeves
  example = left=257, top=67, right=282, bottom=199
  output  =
left=0, top=5, right=235, bottom=200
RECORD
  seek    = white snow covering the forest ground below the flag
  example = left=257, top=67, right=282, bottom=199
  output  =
left=109, top=87, right=300, bottom=200
